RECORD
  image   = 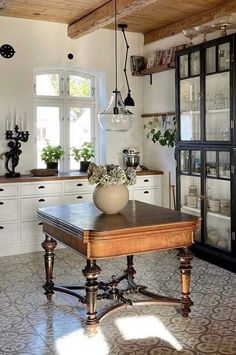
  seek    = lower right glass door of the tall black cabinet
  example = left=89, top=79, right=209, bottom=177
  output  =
left=204, top=151, right=231, bottom=251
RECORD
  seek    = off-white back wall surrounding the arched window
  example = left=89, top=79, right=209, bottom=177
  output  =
left=0, top=17, right=143, bottom=175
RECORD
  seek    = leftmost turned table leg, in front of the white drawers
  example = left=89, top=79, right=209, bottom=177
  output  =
left=41, top=235, right=57, bottom=301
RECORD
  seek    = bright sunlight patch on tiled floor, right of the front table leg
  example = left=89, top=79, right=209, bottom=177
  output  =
left=115, top=316, right=182, bottom=351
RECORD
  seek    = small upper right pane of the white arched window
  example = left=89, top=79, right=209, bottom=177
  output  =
left=69, top=75, right=92, bottom=97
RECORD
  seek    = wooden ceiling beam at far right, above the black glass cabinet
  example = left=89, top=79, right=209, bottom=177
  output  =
left=144, top=0, right=236, bottom=44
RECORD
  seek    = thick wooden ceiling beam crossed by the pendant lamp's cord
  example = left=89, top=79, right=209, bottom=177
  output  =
left=67, top=0, right=157, bottom=38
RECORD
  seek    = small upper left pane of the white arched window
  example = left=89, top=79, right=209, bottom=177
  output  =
left=36, top=74, right=59, bottom=96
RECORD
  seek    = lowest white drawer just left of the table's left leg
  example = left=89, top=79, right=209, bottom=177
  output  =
left=20, top=221, right=45, bottom=245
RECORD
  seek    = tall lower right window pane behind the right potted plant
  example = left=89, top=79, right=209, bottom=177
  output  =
left=69, top=107, right=92, bottom=169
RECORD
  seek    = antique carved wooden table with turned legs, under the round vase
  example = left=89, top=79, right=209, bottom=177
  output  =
left=38, top=201, right=200, bottom=325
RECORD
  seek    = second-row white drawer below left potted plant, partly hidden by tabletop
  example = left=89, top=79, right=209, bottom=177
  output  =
left=21, top=196, right=61, bottom=221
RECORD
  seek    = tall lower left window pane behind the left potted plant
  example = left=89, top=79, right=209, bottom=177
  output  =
left=36, top=106, right=60, bottom=168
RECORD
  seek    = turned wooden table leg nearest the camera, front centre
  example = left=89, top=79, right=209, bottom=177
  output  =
left=82, top=259, right=101, bottom=325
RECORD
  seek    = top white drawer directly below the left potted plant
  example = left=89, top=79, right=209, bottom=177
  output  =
left=21, top=182, right=61, bottom=196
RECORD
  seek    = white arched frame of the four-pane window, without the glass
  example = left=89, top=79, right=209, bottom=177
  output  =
left=33, top=69, right=99, bottom=171
